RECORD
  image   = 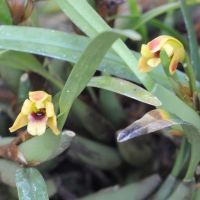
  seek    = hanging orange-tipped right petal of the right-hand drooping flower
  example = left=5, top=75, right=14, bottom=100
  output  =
left=169, top=48, right=185, bottom=75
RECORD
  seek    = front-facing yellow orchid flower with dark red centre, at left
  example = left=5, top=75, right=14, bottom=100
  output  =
left=9, top=91, right=60, bottom=135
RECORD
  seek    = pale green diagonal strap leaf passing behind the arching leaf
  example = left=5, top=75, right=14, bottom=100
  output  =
left=54, top=0, right=155, bottom=90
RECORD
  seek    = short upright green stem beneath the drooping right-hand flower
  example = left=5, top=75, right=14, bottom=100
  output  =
left=183, top=54, right=197, bottom=95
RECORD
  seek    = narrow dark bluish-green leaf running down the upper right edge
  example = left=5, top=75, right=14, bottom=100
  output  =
left=179, top=0, right=200, bottom=81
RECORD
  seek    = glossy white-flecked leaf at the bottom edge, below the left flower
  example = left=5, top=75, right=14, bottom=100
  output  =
left=15, top=168, right=48, bottom=200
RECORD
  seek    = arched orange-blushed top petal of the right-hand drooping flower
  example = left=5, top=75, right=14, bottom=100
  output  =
left=147, top=35, right=183, bottom=53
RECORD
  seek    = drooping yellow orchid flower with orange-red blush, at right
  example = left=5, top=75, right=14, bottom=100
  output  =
left=138, top=35, right=185, bottom=75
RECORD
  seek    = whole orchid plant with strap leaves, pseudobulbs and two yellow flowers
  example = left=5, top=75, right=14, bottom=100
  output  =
left=0, top=0, right=200, bottom=200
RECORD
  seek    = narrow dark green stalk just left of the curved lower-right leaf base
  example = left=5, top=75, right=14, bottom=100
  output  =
left=171, top=137, right=190, bottom=177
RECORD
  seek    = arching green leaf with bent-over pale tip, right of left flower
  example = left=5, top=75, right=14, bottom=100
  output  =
left=59, top=30, right=140, bottom=127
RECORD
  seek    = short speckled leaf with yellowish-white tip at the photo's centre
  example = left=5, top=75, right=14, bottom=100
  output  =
left=87, top=76, right=162, bottom=106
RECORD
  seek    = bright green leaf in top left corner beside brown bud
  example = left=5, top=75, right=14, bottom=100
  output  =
left=0, top=0, right=12, bottom=25
